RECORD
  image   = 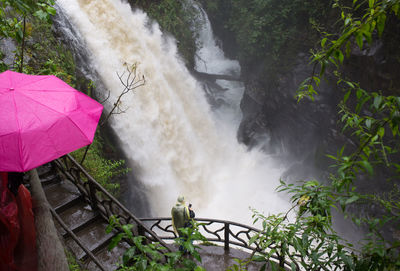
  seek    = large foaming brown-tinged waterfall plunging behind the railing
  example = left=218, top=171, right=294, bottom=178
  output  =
left=57, top=0, right=289, bottom=224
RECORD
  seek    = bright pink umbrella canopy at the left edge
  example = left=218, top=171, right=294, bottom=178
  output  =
left=0, top=71, right=103, bottom=172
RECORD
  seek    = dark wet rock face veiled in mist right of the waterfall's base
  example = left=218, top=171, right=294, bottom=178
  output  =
left=238, top=54, right=339, bottom=177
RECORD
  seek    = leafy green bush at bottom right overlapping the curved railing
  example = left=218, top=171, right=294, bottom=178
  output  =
left=249, top=178, right=400, bottom=270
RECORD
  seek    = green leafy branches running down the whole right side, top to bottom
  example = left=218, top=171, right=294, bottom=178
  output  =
left=250, top=0, right=400, bottom=270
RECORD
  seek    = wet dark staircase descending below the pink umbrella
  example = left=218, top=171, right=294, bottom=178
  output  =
left=34, top=163, right=129, bottom=271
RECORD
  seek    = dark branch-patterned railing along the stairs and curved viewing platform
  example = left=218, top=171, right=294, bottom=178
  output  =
left=54, top=154, right=300, bottom=270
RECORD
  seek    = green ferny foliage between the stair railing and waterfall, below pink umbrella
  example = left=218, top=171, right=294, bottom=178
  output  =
left=72, top=132, right=130, bottom=196
